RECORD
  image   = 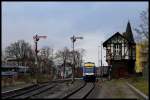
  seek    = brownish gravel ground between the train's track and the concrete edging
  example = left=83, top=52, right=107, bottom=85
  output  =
left=88, top=80, right=139, bottom=99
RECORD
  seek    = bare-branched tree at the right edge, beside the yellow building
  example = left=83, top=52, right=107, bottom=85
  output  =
left=135, top=9, right=149, bottom=79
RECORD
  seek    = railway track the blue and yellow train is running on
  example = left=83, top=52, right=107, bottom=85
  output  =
left=63, top=82, right=95, bottom=99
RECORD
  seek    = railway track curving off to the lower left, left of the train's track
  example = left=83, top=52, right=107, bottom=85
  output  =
left=2, top=80, right=69, bottom=99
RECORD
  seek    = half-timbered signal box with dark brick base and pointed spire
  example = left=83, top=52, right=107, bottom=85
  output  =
left=103, top=22, right=136, bottom=78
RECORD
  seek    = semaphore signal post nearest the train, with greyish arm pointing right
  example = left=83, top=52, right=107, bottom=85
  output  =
left=70, top=35, right=83, bottom=82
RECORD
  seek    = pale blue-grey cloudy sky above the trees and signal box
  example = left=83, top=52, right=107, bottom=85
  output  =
left=2, top=2, right=148, bottom=65
